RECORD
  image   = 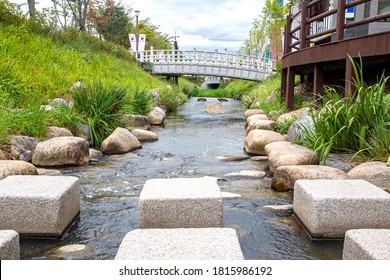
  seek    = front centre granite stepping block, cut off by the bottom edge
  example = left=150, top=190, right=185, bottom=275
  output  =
left=115, top=228, right=244, bottom=260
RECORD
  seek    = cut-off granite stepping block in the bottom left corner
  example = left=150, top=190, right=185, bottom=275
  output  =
left=0, top=230, right=20, bottom=260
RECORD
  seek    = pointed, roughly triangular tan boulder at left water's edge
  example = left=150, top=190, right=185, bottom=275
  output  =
left=100, top=127, right=142, bottom=154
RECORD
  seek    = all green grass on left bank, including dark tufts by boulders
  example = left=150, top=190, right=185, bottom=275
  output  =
left=0, top=1, right=190, bottom=146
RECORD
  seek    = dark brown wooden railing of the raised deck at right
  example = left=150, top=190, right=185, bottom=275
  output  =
left=284, top=0, right=390, bottom=55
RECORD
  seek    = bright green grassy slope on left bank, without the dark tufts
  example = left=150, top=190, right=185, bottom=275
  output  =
left=0, top=24, right=171, bottom=146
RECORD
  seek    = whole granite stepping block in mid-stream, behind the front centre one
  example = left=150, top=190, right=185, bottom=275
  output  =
left=139, top=177, right=223, bottom=228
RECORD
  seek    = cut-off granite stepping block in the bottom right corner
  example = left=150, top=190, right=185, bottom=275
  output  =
left=343, top=229, right=390, bottom=260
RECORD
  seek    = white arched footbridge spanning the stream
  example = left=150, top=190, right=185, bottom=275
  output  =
left=138, top=48, right=275, bottom=81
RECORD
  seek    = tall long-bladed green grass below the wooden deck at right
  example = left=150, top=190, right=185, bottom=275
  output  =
left=303, top=60, right=390, bottom=162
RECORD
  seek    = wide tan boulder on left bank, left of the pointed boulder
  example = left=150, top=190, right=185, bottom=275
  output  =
left=32, top=137, right=89, bottom=166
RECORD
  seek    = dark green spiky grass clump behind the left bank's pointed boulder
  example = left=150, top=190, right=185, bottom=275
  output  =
left=73, top=81, right=127, bottom=147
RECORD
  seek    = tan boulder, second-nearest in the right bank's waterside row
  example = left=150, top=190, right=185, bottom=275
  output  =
left=266, top=141, right=319, bottom=173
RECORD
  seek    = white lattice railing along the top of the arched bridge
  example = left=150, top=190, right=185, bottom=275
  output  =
left=138, top=48, right=276, bottom=73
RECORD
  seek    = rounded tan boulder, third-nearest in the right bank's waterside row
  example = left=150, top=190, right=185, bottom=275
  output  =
left=244, top=129, right=286, bottom=156
